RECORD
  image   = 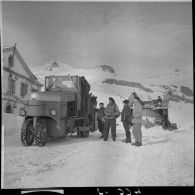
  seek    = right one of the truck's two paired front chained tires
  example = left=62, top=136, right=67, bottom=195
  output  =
left=35, top=119, right=47, bottom=147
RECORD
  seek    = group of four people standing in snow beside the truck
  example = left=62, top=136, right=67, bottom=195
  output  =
left=97, top=94, right=142, bottom=146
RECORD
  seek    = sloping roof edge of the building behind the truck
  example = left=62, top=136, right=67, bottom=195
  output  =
left=3, top=46, right=43, bottom=87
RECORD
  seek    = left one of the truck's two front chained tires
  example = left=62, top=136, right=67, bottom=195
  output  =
left=21, top=119, right=35, bottom=146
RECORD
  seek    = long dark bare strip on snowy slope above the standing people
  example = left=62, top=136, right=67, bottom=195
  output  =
left=102, top=79, right=154, bottom=93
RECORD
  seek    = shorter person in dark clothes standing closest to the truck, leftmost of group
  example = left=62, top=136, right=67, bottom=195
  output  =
left=97, top=103, right=105, bottom=138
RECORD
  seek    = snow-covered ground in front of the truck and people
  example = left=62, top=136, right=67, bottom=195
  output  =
left=4, top=101, right=194, bottom=188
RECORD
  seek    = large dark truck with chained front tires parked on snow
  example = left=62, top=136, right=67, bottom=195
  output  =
left=21, top=75, right=97, bottom=146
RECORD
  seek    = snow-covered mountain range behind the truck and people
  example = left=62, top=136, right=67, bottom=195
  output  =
left=32, top=60, right=193, bottom=104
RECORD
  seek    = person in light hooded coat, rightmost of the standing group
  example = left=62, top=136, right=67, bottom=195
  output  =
left=132, top=96, right=142, bottom=146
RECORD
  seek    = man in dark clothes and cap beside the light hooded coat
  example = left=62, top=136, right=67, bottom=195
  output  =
left=121, top=100, right=131, bottom=143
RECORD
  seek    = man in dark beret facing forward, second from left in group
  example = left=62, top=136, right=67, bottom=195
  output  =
left=104, top=97, right=120, bottom=141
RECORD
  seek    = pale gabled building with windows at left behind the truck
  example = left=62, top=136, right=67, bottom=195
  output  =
left=1, top=46, right=43, bottom=115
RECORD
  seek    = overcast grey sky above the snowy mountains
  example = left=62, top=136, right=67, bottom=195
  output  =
left=2, top=2, right=193, bottom=79
